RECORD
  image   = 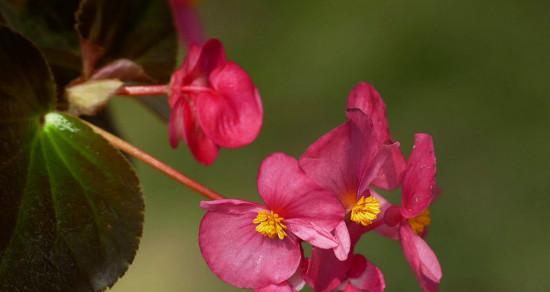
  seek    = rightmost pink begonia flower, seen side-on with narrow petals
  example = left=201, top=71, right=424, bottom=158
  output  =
left=380, top=134, right=442, bottom=292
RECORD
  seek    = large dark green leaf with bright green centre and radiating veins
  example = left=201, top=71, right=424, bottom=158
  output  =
left=0, top=26, right=144, bottom=291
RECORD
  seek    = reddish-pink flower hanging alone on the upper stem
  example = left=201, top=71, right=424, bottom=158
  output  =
left=168, top=40, right=263, bottom=165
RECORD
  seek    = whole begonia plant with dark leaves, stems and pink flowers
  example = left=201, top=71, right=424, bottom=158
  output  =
left=0, top=0, right=442, bottom=292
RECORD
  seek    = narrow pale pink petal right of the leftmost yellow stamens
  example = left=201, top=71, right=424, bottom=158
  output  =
left=285, top=218, right=338, bottom=249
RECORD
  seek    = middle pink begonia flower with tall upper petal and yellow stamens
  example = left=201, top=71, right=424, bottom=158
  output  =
left=300, top=83, right=405, bottom=260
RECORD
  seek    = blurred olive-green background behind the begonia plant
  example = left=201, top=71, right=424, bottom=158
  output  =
left=112, top=0, right=550, bottom=292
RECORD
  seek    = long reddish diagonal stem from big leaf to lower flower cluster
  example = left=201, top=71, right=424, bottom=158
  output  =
left=86, top=122, right=223, bottom=200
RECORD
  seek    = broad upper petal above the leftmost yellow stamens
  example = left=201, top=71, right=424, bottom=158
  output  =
left=258, top=153, right=345, bottom=232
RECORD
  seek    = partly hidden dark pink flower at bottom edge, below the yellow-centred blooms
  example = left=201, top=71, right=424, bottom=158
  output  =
left=305, top=222, right=386, bottom=292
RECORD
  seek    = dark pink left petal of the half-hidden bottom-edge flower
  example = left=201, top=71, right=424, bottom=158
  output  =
left=306, top=248, right=351, bottom=292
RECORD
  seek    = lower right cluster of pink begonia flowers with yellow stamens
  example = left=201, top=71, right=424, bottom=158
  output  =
left=198, top=81, right=442, bottom=291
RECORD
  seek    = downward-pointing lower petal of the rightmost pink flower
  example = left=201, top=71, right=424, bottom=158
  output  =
left=399, top=223, right=442, bottom=291
